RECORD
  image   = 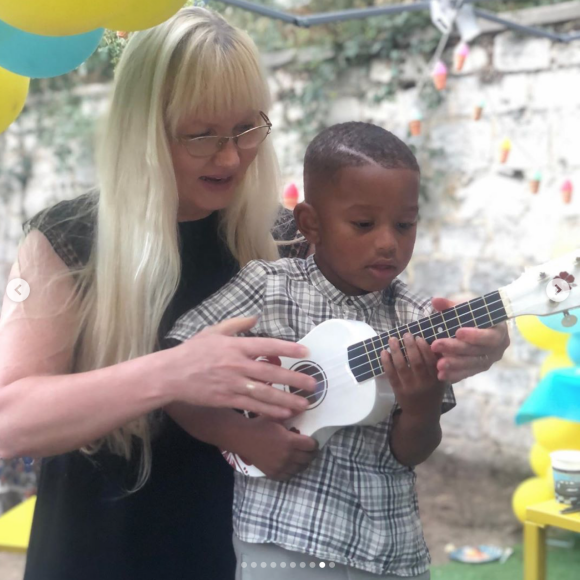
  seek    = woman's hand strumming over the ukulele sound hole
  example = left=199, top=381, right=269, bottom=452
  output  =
left=157, top=317, right=316, bottom=419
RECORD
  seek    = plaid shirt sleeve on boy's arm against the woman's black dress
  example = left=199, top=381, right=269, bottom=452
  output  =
left=166, top=260, right=268, bottom=344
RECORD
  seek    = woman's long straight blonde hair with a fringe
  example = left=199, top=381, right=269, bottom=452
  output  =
left=43, top=7, right=279, bottom=488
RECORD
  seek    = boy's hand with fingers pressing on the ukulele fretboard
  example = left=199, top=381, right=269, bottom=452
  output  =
left=381, top=333, right=445, bottom=417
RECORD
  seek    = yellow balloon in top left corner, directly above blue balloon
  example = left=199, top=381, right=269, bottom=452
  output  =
left=0, top=0, right=131, bottom=36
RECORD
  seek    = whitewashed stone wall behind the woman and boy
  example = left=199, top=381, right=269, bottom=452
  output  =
left=0, top=24, right=580, bottom=469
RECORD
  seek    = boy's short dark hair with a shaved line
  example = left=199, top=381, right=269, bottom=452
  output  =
left=304, top=121, right=420, bottom=193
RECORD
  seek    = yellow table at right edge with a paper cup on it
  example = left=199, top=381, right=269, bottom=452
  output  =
left=524, top=499, right=580, bottom=580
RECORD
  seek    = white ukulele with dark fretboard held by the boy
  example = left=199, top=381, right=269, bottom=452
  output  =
left=223, top=250, right=580, bottom=477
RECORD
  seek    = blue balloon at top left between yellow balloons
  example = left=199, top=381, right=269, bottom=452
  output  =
left=0, top=20, right=104, bottom=78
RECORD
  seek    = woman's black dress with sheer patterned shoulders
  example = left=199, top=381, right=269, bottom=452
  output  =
left=24, top=196, right=307, bottom=580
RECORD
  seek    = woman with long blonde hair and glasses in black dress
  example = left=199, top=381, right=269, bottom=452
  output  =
left=0, top=8, right=315, bottom=580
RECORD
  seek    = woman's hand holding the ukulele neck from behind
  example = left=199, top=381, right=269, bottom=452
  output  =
left=431, top=298, right=510, bottom=383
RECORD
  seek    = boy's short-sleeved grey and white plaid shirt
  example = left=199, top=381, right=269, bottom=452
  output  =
left=168, top=256, right=455, bottom=576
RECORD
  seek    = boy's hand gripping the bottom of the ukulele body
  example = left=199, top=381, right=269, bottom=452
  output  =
left=240, top=417, right=318, bottom=481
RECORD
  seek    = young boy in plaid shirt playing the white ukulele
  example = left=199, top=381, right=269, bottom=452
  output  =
left=168, top=123, right=455, bottom=580
